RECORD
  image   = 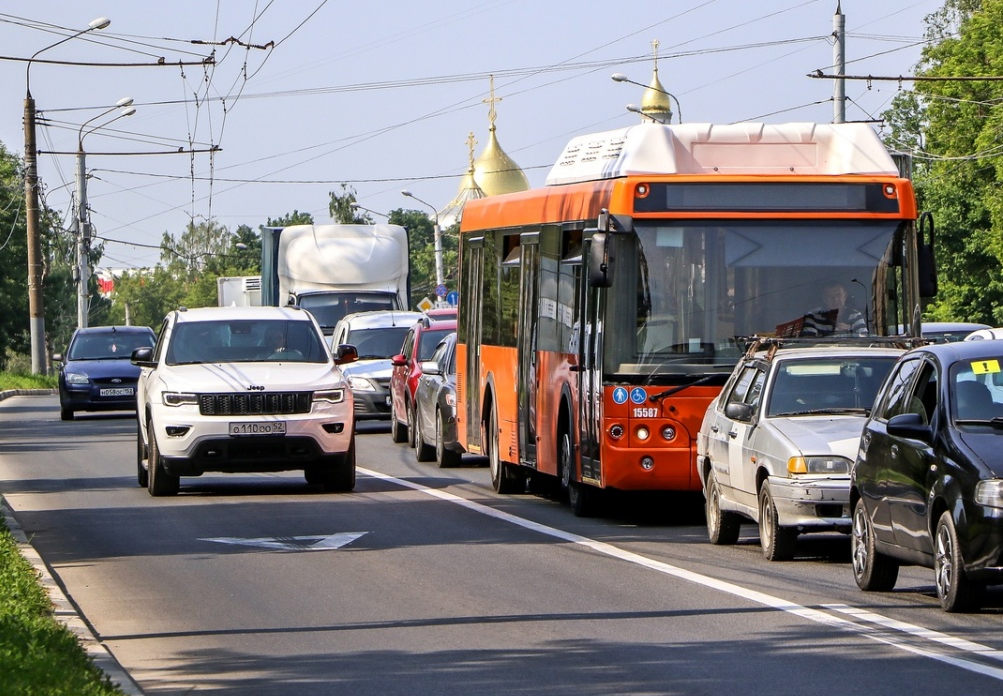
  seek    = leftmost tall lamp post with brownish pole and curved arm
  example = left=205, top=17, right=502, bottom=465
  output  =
left=24, top=17, right=111, bottom=374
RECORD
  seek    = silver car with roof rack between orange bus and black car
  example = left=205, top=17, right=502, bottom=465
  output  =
left=697, top=345, right=904, bottom=561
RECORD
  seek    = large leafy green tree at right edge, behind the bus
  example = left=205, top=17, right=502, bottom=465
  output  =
left=886, top=0, right=1003, bottom=326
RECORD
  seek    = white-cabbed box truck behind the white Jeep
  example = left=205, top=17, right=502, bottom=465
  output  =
left=262, top=225, right=410, bottom=334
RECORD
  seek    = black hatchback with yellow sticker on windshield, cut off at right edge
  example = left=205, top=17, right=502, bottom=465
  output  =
left=850, top=341, right=1003, bottom=612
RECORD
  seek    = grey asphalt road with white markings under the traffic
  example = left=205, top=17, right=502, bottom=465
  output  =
left=0, top=396, right=1003, bottom=696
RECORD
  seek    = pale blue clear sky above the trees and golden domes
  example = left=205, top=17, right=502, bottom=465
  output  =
left=0, top=0, right=943, bottom=268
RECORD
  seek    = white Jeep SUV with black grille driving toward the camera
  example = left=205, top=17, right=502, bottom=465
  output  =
left=132, top=307, right=356, bottom=495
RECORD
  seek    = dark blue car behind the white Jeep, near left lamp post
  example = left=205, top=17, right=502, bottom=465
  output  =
left=52, top=326, right=156, bottom=420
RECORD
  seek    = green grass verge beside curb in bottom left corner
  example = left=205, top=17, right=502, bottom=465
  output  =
left=0, top=509, right=123, bottom=696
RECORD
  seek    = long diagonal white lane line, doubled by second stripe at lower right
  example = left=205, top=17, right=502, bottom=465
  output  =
left=357, top=467, right=1003, bottom=681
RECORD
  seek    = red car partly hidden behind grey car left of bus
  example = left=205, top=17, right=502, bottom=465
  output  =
left=390, top=310, right=456, bottom=446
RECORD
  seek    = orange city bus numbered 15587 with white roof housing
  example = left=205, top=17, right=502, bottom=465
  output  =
left=456, top=123, right=933, bottom=515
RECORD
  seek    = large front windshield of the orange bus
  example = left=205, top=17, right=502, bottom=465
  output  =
left=603, top=220, right=899, bottom=377
